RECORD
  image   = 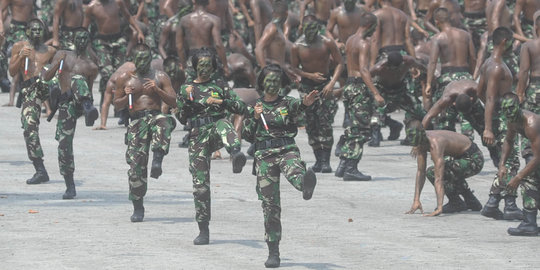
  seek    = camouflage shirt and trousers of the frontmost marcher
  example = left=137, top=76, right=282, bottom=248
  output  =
left=242, top=96, right=306, bottom=242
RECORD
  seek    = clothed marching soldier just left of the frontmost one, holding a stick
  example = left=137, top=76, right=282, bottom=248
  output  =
left=177, top=49, right=246, bottom=245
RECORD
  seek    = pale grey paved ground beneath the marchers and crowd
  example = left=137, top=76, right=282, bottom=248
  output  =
left=0, top=89, right=540, bottom=269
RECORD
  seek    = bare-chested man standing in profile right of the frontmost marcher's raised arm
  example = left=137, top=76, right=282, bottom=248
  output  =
left=335, top=12, right=384, bottom=181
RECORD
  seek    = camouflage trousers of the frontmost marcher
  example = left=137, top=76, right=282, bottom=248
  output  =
left=255, top=144, right=306, bottom=242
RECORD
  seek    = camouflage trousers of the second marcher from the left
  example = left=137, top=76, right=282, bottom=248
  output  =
left=55, top=75, right=92, bottom=176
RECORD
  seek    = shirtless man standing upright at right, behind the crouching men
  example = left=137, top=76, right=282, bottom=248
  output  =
left=477, top=27, right=522, bottom=219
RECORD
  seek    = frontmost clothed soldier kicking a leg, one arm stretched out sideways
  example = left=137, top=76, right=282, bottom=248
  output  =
left=243, top=64, right=318, bottom=268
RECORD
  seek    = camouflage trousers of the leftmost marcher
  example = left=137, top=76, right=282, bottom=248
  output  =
left=20, top=79, right=49, bottom=161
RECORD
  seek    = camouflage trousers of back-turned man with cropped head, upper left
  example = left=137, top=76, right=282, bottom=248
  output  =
left=92, top=33, right=127, bottom=93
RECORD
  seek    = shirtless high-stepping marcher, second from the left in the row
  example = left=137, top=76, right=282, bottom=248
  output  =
left=44, top=27, right=98, bottom=199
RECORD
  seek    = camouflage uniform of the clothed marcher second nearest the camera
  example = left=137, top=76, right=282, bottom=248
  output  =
left=177, top=81, right=246, bottom=222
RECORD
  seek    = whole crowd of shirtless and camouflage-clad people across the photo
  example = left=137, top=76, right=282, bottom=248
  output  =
left=0, top=0, right=540, bottom=267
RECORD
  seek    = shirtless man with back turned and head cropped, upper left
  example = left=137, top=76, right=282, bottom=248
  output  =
left=83, top=0, right=144, bottom=104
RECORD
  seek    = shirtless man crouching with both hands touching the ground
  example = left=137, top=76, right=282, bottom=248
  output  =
left=406, top=121, right=484, bottom=217
